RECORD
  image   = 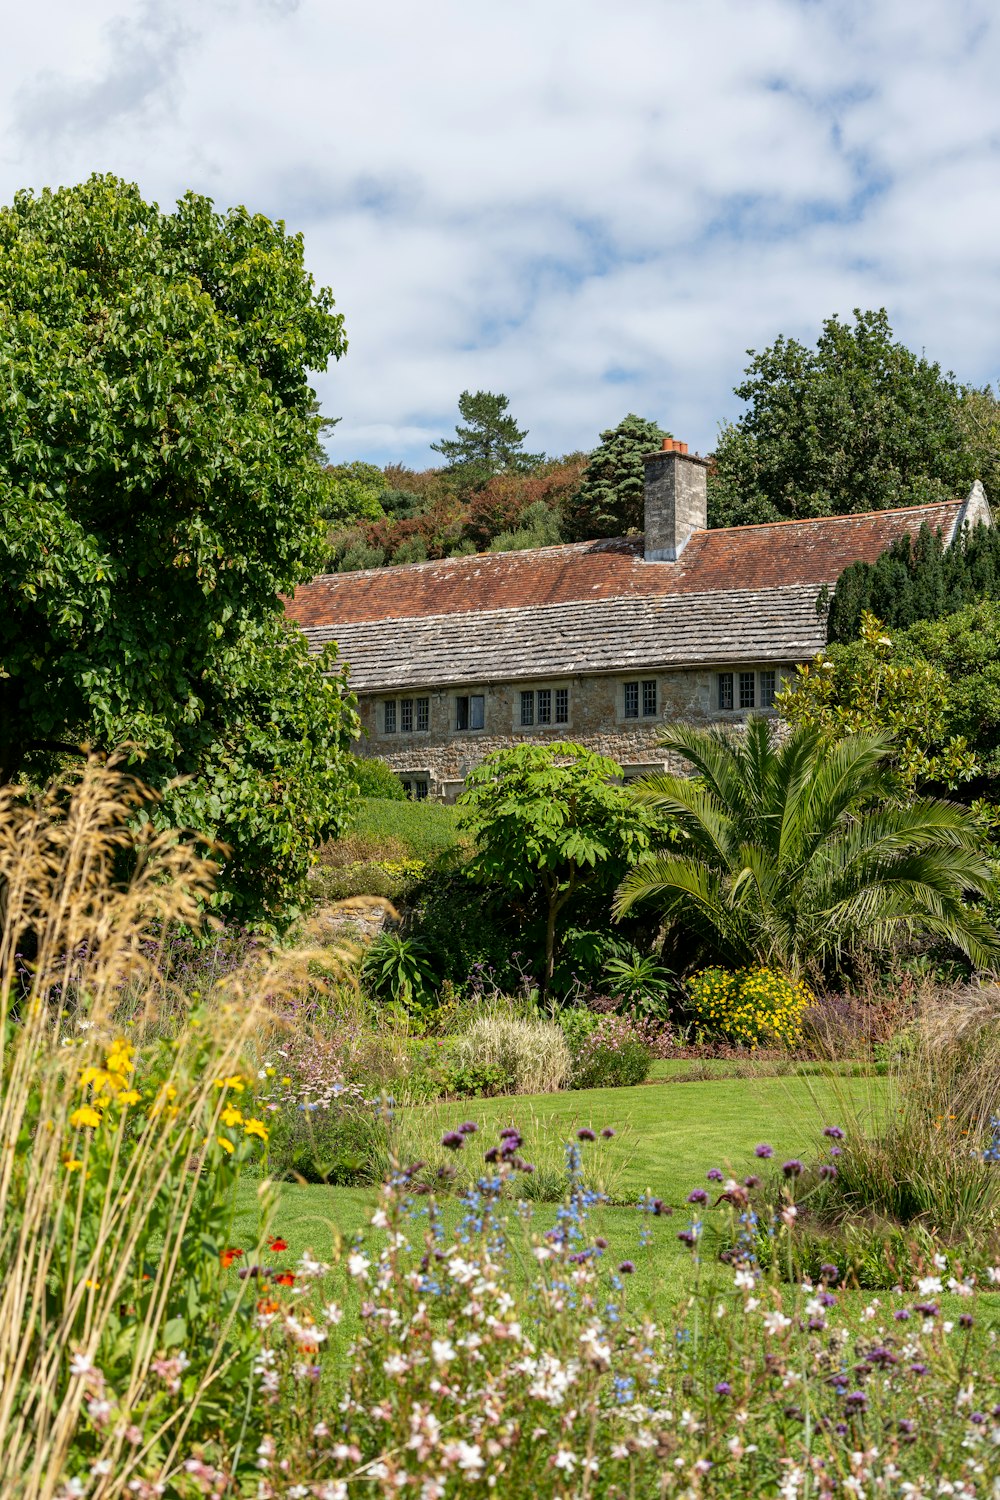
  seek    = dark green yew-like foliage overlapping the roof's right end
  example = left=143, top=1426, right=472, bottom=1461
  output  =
left=826, top=524, right=1000, bottom=642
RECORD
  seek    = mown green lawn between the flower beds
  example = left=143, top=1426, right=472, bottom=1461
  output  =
left=230, top=1077, right=885, bottom=1301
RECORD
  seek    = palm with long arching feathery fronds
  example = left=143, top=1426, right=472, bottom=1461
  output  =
left=615, top=719, right=1000, bottom=978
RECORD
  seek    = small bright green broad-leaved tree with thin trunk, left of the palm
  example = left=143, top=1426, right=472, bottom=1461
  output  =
left=462, top=743, right=649, bottom=986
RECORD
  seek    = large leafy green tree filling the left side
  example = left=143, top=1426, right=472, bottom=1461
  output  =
left=0, top=177, right=355, bottom=918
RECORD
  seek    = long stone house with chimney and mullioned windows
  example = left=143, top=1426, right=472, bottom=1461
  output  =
left=286, top=440, right=993, bottom=801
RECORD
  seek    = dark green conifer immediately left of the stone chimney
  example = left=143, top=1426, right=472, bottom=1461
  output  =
left=564, top=413, right=670, bottom=542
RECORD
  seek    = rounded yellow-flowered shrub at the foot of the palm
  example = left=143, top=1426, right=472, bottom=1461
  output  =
left=687, top=968, right=816, bottom=1047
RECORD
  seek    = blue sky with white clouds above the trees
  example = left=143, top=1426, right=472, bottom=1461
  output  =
left=0, top=0, right=1000, bottom=468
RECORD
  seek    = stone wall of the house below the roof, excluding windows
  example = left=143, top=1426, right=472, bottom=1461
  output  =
left=358, top=662, right=792, bottom=803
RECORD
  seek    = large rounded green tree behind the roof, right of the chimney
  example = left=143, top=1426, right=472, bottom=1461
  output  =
left=709, top=308, right=997, bottom=527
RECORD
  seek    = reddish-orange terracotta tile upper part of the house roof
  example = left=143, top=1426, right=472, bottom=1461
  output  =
left=286, top=501, right=963, bottom=627
